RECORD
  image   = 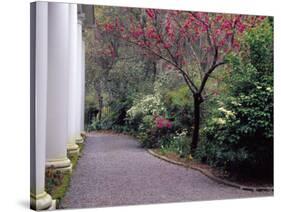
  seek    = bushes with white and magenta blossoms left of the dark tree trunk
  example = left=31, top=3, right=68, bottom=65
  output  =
left=127, top=81, right=192, bottom=149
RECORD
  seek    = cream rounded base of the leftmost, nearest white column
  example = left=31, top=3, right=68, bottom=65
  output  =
left=30, top=191, right=53, bottom=210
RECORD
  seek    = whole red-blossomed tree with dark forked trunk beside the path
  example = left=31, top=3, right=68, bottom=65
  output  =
left=101, top=8, right=265, bottom=153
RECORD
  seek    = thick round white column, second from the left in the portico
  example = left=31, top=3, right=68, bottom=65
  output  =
left=46, top=3, right=72, bottom=171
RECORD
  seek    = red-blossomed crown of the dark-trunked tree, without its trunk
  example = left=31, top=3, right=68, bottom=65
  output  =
left=101, top=9, right=265, bottom=75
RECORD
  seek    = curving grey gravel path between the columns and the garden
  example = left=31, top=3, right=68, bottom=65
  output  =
left=59, top=133, right=273, bottom=208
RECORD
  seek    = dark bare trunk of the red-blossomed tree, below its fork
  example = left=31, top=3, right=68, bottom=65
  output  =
left=191, top=94, right=202, bottom=154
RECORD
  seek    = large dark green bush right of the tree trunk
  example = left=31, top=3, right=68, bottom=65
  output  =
left=197, top=19, right=273, bottom=178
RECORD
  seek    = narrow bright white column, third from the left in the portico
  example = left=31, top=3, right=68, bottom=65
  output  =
left=67, top=4, right=79, bottom=154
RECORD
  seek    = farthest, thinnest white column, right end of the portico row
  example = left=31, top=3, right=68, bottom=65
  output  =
left=75, top=17, right=83, bottom=143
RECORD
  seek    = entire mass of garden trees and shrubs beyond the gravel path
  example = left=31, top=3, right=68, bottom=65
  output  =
left=85, top=6, right=273, bottom=183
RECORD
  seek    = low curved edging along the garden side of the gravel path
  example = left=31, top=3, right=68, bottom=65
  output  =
left=146, top=149, right=274, bottom=192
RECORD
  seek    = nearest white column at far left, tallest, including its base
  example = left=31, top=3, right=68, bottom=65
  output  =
left=30, top=2, right=54, bottom=210
